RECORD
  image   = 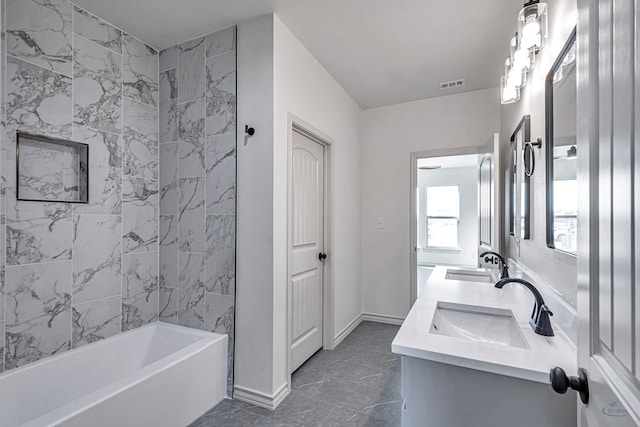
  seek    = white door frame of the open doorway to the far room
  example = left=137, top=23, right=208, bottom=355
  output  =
left=409, top=145, right=493, bottom=307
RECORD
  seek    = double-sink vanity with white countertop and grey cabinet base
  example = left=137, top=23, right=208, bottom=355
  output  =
left=391, top=263, right=577, bottom=427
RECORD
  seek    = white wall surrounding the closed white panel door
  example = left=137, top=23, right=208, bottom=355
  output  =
left=274, top=11, right=362, bottom=366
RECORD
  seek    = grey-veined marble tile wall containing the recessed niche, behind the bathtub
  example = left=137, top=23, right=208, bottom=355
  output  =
left=0, top=0, right=159, bottom=372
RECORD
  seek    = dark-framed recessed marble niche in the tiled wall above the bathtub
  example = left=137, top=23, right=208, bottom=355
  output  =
left=16, top=132, right=89, bottom=203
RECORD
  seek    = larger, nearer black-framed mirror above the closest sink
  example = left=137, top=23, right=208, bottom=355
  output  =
left=545, top=29, right=578, bottom=255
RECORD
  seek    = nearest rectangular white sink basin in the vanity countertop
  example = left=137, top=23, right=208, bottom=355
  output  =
left=429, top=301, right=529, bottom=348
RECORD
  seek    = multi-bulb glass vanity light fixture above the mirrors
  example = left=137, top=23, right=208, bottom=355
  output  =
left=500, top=0, right=547, bottom=104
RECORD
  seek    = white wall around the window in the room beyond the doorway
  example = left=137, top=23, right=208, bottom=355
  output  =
left=418, top=166, right=478, bottom=266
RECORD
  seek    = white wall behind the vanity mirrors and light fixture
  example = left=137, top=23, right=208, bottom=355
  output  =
left=501, top=0, right=580, bottom=305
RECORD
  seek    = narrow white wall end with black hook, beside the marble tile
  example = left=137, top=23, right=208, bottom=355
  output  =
left=234, top=16, right=274, bottom=402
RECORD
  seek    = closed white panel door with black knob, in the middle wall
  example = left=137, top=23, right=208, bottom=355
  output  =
left=289, top=131, right=326, bottom=372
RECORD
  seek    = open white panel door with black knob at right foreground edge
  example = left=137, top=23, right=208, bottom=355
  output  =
left=571, top=0, right=640, bottom=427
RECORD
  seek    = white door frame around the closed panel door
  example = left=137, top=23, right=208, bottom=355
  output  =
left=287, top=112, right=335, bottom=389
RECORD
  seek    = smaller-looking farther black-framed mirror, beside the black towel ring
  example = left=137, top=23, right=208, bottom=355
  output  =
left=509, top=115, right=531, bottom=239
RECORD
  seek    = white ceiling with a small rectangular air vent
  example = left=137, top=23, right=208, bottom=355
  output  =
left=75, top=0, right=522, bottom=108
